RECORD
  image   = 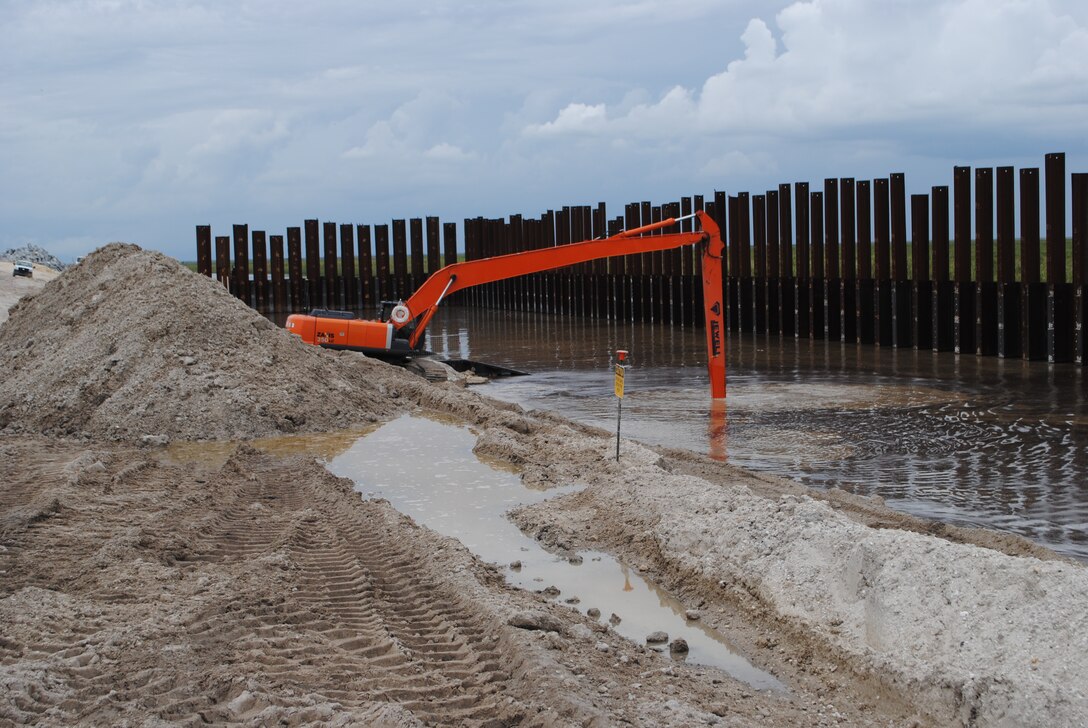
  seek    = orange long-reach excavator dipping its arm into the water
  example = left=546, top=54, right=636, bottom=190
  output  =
left=287, top=206, right=726, bottom=399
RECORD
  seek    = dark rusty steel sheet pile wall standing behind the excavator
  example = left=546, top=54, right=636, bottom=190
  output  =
left=197, top=153, right=1088, bottom=365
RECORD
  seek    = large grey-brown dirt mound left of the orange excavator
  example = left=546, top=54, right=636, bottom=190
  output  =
left=0, top=244, right=413, bottom=442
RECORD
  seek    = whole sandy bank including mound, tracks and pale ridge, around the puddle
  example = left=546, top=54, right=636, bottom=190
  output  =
left=0, top=246, right=1088, bottom=726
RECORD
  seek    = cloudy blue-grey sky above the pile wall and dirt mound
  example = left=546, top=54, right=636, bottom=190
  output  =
left=0, top=0, right=1088, bottom=261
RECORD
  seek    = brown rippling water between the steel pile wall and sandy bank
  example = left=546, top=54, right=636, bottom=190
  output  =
left=429, top=309, right=1088, bottom=559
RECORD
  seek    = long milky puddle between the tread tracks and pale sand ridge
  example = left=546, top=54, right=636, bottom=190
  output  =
left=326, top=417, right=786, bottom=690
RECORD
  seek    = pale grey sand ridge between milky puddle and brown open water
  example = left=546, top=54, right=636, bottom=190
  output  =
left=478, top=428, right=1088, bottom=727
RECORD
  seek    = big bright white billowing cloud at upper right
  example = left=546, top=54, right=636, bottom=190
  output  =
left=524, top=0, right=1088, bottom=140
